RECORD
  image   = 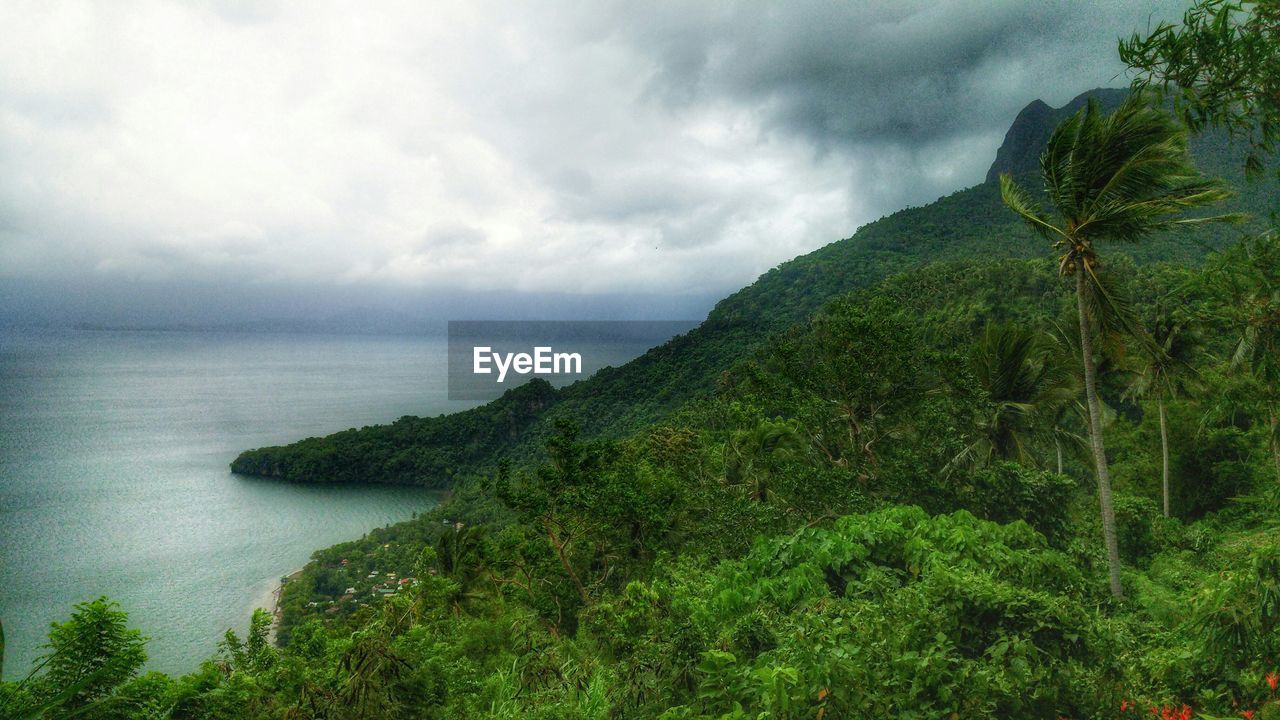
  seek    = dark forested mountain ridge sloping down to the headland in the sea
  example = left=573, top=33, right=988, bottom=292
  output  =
left=232, top=88, right=1277, bottom=487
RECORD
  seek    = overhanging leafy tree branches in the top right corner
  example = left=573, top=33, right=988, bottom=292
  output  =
left=1120, top=0, right=1280, bottom=173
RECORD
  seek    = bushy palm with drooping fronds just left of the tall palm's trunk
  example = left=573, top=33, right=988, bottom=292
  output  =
left=961, top=323, right=1075, bottom=473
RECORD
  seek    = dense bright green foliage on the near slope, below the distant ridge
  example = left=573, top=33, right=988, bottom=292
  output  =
left=4, top=238, right=1280, bottom=717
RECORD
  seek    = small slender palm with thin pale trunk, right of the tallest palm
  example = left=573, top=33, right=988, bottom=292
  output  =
left=1128, top=302, right=1201, bottom=518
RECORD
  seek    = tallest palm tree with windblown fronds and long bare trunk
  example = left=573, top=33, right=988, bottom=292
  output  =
left=1000, top=95, right=1228, bottom=597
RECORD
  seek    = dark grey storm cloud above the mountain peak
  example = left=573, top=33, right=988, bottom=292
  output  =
left=608, top=0, right=1184, bottom=145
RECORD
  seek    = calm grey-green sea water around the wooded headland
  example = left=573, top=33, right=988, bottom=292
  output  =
left=0, top=331, right=475, bottom=679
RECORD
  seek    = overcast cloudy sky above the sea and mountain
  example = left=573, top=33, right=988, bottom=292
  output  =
left=0, top=0, right=1184, bottom=319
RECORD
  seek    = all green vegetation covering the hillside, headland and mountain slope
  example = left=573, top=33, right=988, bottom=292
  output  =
left=0, top=0, right=1280, bottom=720
